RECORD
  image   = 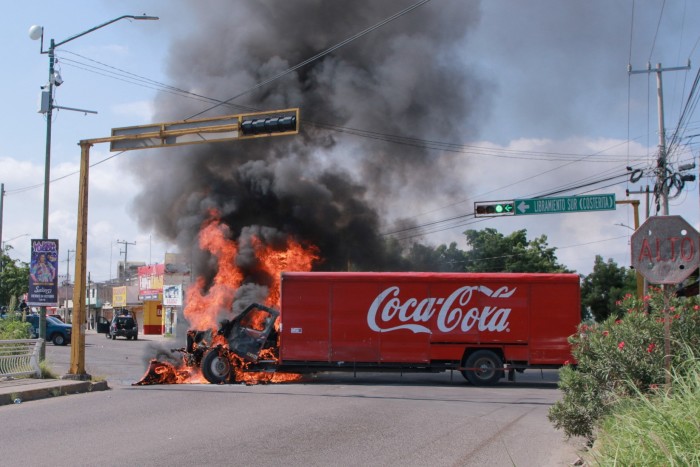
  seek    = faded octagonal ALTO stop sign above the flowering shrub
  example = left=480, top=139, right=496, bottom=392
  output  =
left=632, top=216, right=700, bottom=284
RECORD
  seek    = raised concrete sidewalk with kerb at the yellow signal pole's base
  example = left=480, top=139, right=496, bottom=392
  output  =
left=0, top=378, right=109, bottom=405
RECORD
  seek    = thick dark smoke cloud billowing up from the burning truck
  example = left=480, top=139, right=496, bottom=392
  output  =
left=127, top=0, right=490, bottom=282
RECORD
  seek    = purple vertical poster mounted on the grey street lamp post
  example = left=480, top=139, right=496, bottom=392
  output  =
left=27, top=239, right=58, bottom=306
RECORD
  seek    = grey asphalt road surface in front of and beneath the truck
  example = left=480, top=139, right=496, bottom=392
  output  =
left=0, top=334, right=578, bottom=466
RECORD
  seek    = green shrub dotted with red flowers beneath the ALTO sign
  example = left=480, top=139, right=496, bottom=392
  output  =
left=549, top=289, right=700, bottom=442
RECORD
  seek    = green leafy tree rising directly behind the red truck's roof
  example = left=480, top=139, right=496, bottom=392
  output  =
left=464, top=228, right=571, bottom=273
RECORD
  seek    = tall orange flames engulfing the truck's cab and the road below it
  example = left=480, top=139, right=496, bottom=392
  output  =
left=134, top=212, right=317, bottom=386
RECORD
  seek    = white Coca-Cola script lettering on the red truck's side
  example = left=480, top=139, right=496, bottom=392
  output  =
left=367, top=285, right=516, bottom=333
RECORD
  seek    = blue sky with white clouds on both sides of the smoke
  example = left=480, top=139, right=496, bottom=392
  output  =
left=0, top=0, right=700, bottom=280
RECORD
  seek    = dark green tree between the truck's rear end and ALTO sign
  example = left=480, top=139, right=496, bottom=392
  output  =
left=581, top=255, right=637, bottom=322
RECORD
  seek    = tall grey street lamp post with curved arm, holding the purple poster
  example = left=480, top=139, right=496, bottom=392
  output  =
left=29, top=15, right=158, bottom=359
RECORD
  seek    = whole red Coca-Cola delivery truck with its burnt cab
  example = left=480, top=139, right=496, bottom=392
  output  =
left=182, top=272, right=580, bottom=385
